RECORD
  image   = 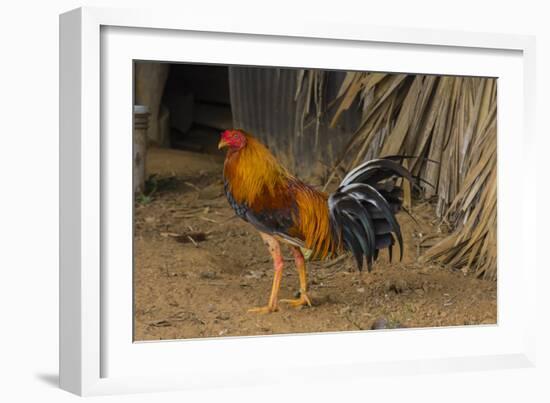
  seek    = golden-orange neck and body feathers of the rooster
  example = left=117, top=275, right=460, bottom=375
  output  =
left=224, top=134, right=338, bottom=258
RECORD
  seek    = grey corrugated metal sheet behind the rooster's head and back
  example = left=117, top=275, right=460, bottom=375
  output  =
left=229, top=66, right=360, bottom=175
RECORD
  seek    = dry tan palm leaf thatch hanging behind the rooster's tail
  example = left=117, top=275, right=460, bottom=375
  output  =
left=322, top=72, right=497, bottom=279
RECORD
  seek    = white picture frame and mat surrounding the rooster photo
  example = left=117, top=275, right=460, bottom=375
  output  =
left=60, top=8, right=536, bottom=395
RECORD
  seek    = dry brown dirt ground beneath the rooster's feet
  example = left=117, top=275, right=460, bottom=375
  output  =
left=134, top=150, right=497, bottom=340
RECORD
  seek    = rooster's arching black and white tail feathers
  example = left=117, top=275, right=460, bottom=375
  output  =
left=328, top=156, right=414, bottom=271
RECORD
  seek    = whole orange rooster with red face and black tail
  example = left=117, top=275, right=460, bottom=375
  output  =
left=218, top=129, right=414, bottom=313
